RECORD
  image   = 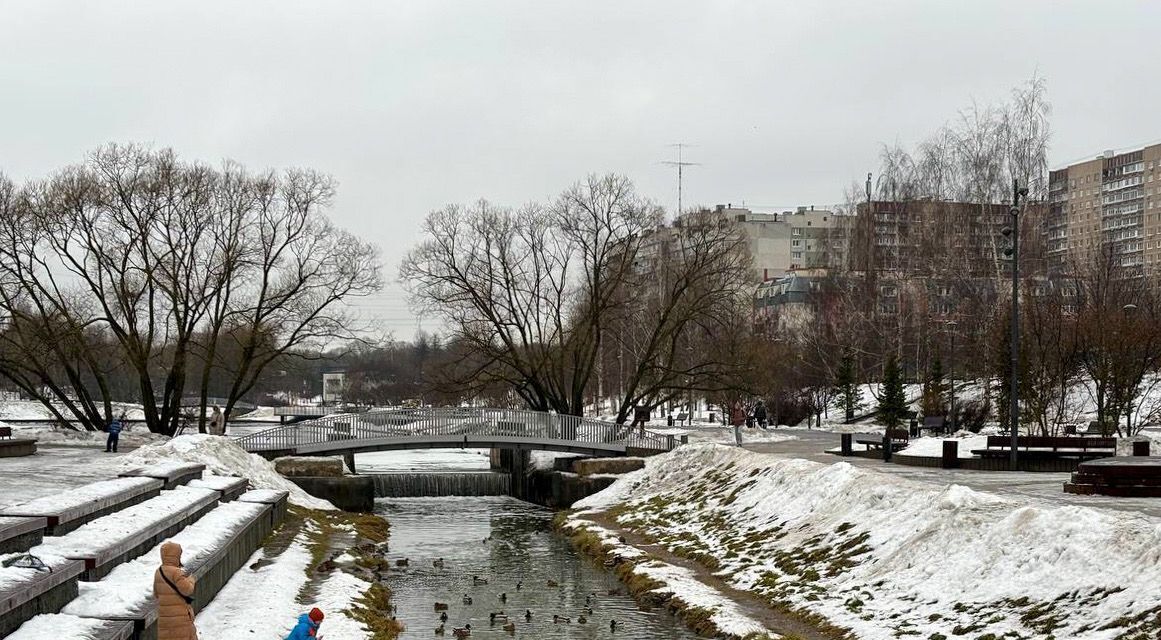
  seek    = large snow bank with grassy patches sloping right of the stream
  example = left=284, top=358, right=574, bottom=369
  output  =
left=575, top=445, right=1161, bottom=640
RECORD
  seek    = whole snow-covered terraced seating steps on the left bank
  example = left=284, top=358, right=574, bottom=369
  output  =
left=0, top=463, right=288, bottom=640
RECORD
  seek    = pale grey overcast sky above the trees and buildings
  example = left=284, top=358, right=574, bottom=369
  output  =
left=0, top=0, right=1161, bottom=338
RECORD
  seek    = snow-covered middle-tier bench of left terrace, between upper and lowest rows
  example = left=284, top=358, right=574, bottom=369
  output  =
left=31, top=487, right=221, bottom=582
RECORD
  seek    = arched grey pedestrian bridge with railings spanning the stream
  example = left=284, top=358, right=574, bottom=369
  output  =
left=236, top=408, right=676, bottom=458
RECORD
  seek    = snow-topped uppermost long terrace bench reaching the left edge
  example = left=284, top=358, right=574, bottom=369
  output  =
left=0, top=477, right=165, bottom=535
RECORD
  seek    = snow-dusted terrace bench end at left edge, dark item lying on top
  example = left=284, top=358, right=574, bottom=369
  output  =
left=0, top=554, right=85, bottom=638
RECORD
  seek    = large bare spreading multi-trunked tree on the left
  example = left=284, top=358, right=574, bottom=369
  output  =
left=0, top=145, right=380, bottom=433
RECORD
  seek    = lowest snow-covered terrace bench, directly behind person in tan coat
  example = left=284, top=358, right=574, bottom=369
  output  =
left=60, top=499, right=271, bottom=639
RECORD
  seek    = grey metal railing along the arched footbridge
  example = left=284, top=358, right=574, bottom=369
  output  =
left=236, top=407, right=676, bottom=452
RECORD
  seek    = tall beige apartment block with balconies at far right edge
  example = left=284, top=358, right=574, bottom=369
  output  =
left=1044, top=144, right=1161, bottom=271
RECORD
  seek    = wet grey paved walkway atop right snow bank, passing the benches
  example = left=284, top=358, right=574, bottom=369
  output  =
left=742, top=429, right=1161, bottom=518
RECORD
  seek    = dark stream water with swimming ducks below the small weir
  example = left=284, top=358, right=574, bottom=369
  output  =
left=376, top=497, right=697, bottom=640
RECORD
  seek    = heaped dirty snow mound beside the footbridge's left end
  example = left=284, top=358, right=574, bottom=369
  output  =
left=122, top=433, right=334, bottom=510
